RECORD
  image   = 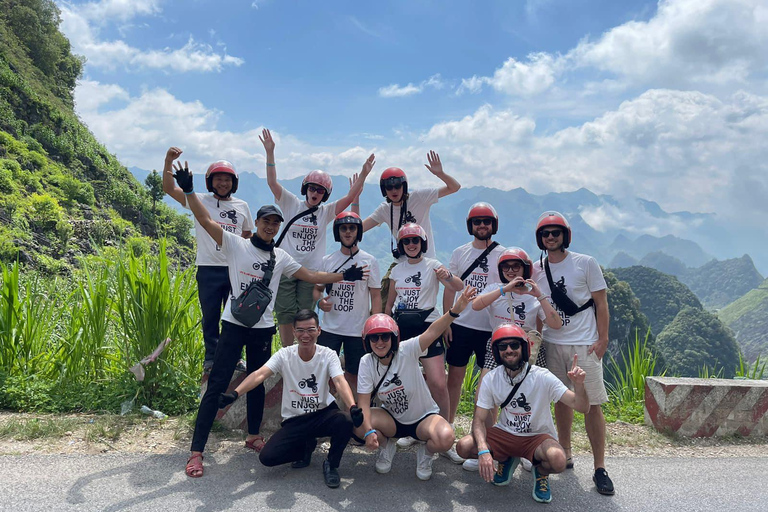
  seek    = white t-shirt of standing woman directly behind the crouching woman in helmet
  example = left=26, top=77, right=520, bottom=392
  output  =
left=389, top=257, right=442, bottom=322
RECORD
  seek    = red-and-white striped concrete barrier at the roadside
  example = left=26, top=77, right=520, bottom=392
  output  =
left=645, top=377, right=768, bottom=437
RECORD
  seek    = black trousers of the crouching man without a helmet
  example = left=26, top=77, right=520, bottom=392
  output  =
left=259, top=402, right=352, bottom=468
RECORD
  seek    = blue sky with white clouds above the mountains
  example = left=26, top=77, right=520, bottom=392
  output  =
left=58, top=0, right=768, bottom=239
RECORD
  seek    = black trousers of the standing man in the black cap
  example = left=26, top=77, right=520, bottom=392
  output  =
left=192, top=321, right=275, bottom=452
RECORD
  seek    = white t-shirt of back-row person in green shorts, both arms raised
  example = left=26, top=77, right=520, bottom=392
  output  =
left=277, top=187, right=336, bottom=270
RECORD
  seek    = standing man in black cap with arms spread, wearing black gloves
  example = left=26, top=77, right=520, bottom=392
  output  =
left=174, top=164, right=368, bottom=478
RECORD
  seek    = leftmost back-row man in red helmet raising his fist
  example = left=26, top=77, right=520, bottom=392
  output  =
left=163, top=147, right=253, bottom=372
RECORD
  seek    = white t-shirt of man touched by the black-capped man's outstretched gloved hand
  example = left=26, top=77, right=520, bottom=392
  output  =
left=320, top=250, right=381, bottom=337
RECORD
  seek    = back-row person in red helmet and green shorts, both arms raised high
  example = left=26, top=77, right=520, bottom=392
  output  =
left=259, top=129, right=376, bottom=347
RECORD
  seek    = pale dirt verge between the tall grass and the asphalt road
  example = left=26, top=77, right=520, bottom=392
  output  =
left=0, top=412, right=768, bottom=457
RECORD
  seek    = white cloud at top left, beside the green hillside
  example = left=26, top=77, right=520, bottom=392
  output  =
left=61, top=0, right=244, bottom=73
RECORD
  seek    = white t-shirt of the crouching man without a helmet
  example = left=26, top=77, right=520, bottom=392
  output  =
left=265, top=345, right=344, bottom=420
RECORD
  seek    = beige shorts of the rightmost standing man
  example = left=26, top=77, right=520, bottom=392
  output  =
left=544, top=340, right=608, bottom=405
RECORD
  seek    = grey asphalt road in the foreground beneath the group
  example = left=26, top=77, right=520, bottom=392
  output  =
left=0, top=451, right=768, bottom=512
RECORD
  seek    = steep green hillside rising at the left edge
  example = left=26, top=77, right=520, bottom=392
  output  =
left=0, top=0, right=192, bottom=271
